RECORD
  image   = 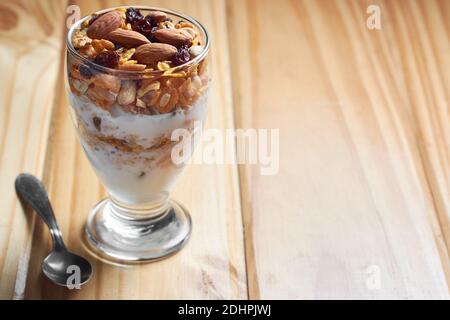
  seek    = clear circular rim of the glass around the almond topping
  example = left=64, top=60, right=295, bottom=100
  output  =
left=66, top=6, right=210, bottom=76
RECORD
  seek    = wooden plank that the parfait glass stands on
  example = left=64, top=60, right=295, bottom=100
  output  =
left=22, top=0, right=247, bottom=299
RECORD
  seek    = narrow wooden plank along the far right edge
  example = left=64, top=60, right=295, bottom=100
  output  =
left=395, top=1, right=450, bottom=279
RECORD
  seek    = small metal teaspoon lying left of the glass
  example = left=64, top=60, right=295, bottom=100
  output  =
left=15, top=173, right=92, bottom=287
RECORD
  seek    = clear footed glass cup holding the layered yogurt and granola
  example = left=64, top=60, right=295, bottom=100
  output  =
left=66, top=6, right=210, bottom=263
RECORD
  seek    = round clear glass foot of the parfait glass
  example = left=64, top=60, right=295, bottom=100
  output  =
left=85, top=198, right=192, bottom=264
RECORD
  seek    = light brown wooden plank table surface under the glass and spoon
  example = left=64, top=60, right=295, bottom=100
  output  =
left=0, top=0, right=450, bottom=299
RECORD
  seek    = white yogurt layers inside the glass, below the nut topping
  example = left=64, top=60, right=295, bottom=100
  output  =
left=69, top=92, right=208, bottom=206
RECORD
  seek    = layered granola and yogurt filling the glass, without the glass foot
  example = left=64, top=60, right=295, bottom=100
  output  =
left=67, top=7, right=210, bottom=204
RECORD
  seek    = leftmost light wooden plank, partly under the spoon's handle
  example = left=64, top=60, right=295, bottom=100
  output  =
left=0, top=0, right=65, bottom=299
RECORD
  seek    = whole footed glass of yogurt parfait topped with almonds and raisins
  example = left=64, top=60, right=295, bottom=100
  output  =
left=66, top=7, right=210, bottom=262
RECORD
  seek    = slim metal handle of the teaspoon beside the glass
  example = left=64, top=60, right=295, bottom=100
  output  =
left=15, top=173, right=66, bottom=249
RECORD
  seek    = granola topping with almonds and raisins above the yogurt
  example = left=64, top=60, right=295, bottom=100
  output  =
left=68, top=7, right=209, bottom=114
